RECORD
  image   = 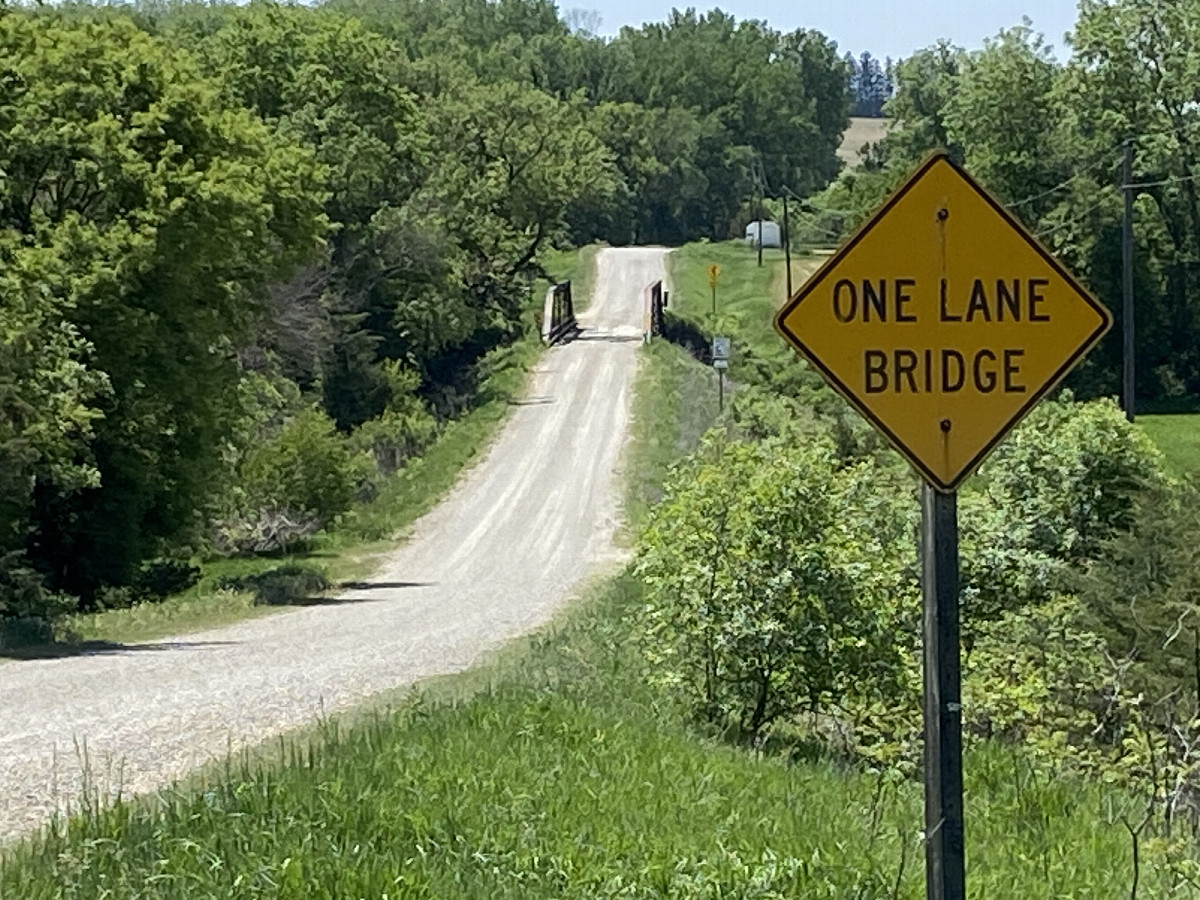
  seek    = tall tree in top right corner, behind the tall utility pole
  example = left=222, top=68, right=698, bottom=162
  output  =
left=1063, top=0, right=1200, bottom=394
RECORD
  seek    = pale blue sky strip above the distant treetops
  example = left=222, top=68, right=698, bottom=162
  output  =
left=558, top=0, right=1076, bottom=60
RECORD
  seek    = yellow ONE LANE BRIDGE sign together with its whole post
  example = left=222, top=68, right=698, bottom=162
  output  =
left=772, top=152, right=1112, bottom=900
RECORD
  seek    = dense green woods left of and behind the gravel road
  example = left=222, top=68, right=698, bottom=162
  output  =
left=0, top=0, right=848, bottom=617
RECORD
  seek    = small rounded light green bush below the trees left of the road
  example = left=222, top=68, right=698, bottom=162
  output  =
left=234, top=408, right=370, bottom=526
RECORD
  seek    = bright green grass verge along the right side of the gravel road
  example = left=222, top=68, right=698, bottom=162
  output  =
left=0, top=243, right=1189, bottom=900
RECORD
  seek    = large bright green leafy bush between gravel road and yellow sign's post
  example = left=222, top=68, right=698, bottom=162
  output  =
left=636, top=431, right=899, bottom=739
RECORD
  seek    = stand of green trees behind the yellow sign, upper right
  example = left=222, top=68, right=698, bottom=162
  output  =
left=810, top=0, right=1200, bottom=404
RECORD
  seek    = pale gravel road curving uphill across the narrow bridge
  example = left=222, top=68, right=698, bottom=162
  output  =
left=0, top=248, right=666, bottom=840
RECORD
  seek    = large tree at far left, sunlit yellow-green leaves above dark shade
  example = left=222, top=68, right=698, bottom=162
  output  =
left=0, top=14, right=325, bottom=596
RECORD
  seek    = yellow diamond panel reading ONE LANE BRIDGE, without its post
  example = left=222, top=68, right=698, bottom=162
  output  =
left=775, top=152, right=1112, bottom=491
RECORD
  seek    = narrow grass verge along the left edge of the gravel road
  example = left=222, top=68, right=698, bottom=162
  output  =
left=16, top=246, right=599, bottom=658
